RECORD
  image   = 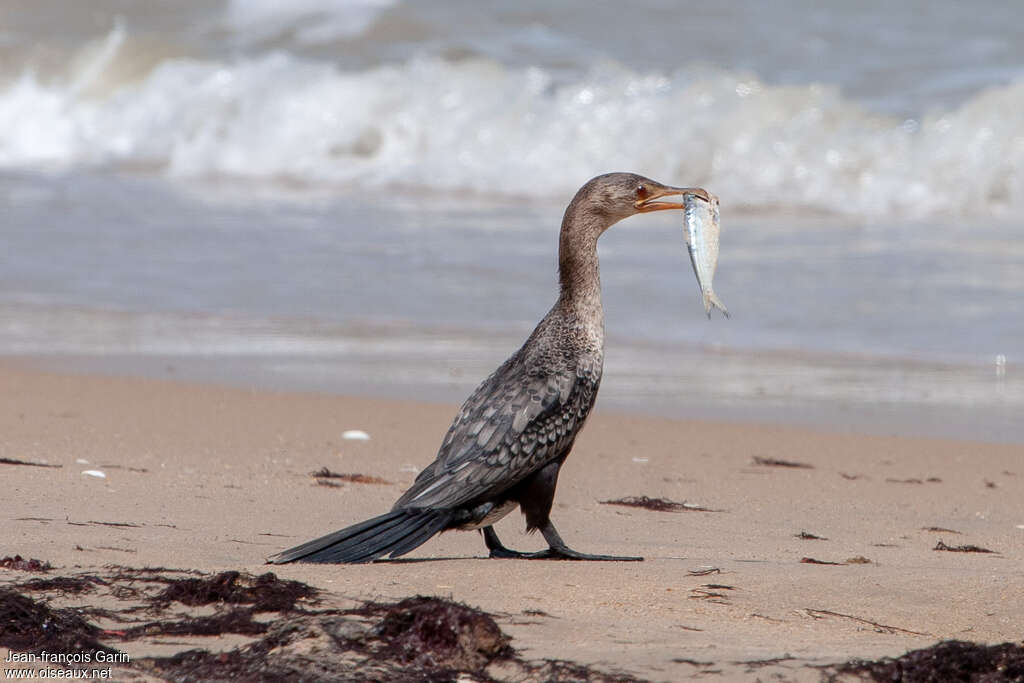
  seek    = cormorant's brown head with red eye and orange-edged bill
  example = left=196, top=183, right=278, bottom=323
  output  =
left=569, top=173, right=710, bottom=229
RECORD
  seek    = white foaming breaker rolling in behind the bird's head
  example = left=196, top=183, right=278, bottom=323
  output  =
left=0, top=26, right=1024, bottom=217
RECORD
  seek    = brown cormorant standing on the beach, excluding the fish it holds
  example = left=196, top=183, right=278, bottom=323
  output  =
left=267, top=173, right=709, bottom=564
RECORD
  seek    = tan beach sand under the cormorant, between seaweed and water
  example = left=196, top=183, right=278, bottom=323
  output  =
left=0, top=360, right=1024, bottom=680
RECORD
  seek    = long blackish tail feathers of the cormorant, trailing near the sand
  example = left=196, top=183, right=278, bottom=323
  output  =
left=267, top=509, right=452, bottom=564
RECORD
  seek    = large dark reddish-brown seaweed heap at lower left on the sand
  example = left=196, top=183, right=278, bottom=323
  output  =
left=0, top=566, right=655, bottom=683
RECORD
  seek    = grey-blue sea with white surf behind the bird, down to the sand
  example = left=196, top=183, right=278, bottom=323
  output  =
left=0, top=0, right=1024, bottom=441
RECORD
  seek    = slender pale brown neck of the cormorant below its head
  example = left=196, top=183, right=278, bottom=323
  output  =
left=558, top=206, right=604, bottom=331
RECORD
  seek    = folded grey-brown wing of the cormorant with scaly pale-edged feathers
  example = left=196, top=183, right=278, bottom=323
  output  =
left=394, top=354, right=601, bottom=509
